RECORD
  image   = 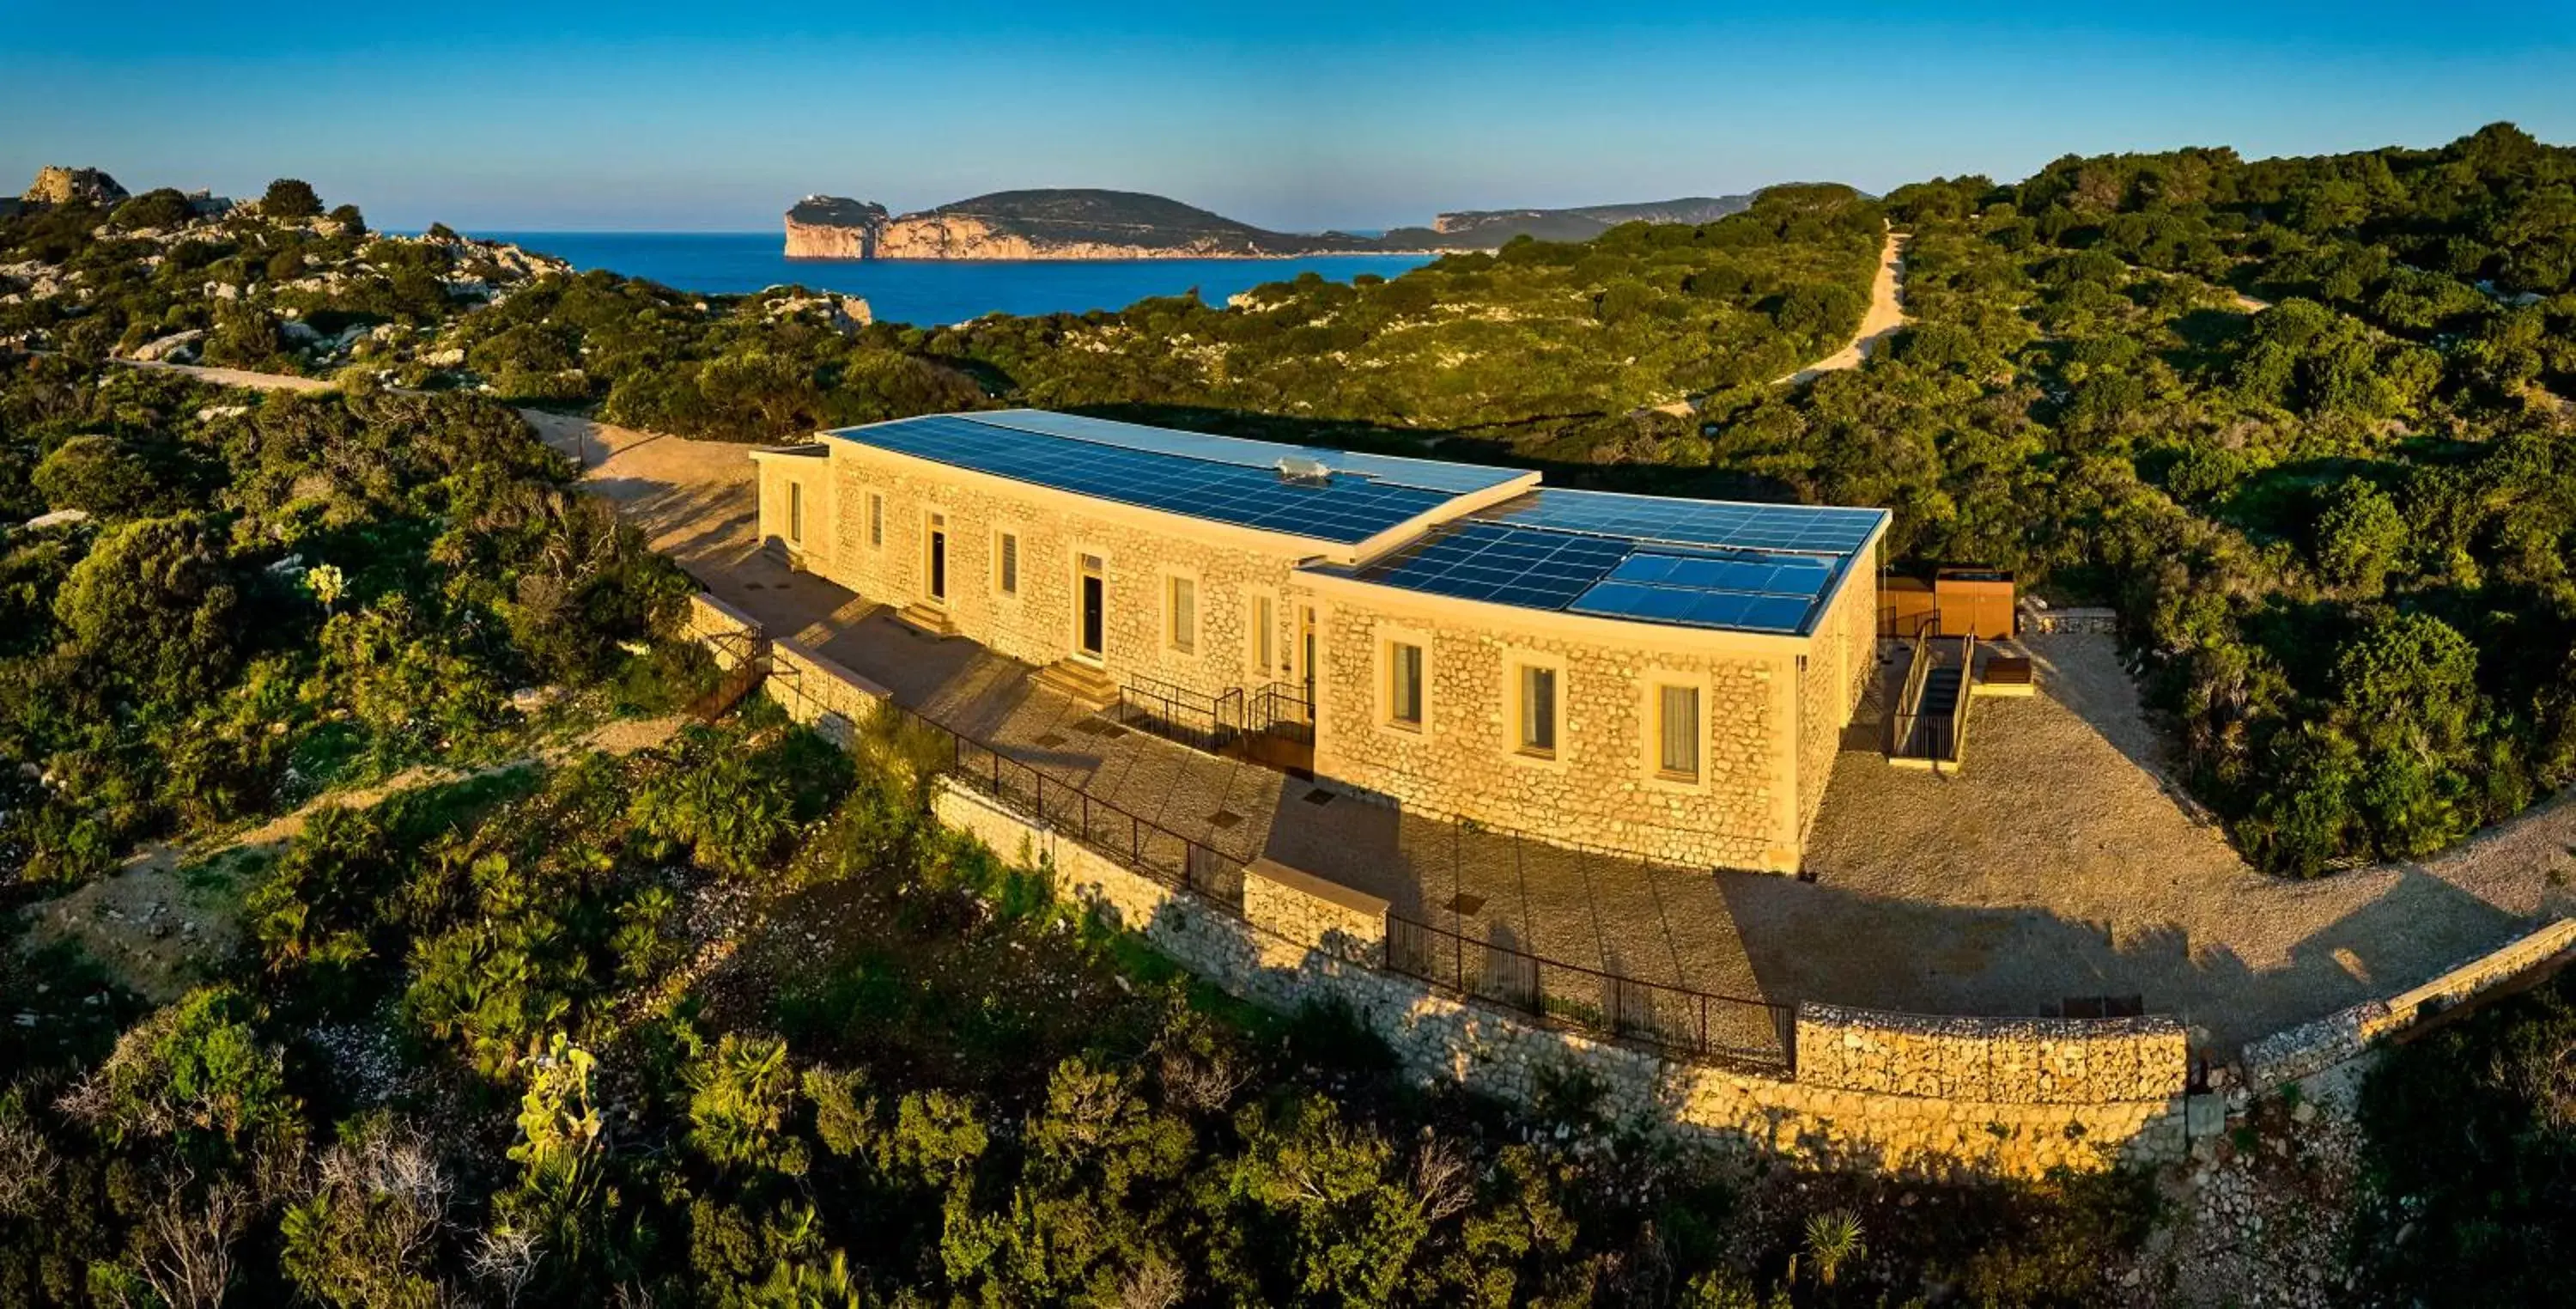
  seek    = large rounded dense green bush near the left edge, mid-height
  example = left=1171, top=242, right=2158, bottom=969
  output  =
left=54, top=513, right=240, bottom=698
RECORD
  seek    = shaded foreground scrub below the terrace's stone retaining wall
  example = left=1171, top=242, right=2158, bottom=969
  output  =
left=0, top=701, right=2148, bottom=1306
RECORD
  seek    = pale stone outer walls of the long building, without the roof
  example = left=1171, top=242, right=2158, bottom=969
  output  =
left=755, top=417, right=1878, bottom=871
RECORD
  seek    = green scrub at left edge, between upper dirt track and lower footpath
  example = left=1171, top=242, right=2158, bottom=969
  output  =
left=0, top=358, right=703, bottom=881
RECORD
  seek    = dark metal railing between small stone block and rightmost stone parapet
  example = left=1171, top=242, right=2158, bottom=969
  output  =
left=1386, top=912, right=1798, bottom=1072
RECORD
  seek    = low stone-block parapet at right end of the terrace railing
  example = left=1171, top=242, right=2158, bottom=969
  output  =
left=1798, top=1005, right=2190, bottom=1105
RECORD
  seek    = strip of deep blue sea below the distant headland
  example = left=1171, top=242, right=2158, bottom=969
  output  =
left=474, top=232, right=1430, bottom=327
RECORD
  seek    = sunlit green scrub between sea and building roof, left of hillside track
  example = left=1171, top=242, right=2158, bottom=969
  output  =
left=927, top=186, right=1886, bottom=438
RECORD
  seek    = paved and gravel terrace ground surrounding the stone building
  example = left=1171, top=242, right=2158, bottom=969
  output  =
left=531, top=415, right=2576, bottom=1054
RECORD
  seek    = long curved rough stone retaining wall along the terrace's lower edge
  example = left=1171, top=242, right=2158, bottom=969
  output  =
left=935, top=783, right=2187, bottom=1178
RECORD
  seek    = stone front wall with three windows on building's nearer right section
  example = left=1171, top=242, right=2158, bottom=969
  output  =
left=1314, top=590, right=1798, bottom=871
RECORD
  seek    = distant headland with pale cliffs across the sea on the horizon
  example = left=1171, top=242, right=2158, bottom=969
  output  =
left=786, top=188, right=1752, bottom=260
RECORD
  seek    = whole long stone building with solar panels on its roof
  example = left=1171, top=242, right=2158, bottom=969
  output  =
left=752, top=410, right=1888, bottom=871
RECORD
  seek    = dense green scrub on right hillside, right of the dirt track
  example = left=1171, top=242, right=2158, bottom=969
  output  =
left=1649, top=126, right=2576, bottom=874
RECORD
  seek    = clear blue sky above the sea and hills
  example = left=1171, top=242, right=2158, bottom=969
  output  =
left=0, top=0, right=2576, bottom=232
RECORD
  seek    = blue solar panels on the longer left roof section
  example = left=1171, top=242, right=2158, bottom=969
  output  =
left=827, top=415, right=1450, bottom=544
